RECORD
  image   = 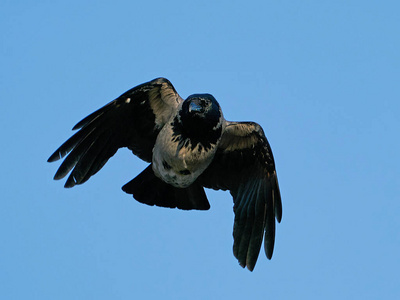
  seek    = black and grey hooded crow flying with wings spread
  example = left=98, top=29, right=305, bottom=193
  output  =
left=48, top=77, right=282, bottom=271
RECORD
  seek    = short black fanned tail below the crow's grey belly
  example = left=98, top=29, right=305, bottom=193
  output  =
left=122, top=165, right=210, bottom=210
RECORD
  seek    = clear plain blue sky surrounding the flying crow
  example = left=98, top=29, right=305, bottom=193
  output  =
left=0, top=0, right=400, bottom=299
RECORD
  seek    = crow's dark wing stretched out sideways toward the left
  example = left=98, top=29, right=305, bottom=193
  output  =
left=48, top=78, right=183, bottom=187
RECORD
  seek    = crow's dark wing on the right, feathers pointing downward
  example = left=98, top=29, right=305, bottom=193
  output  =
left=199, top=122, right=282, bottom=271
